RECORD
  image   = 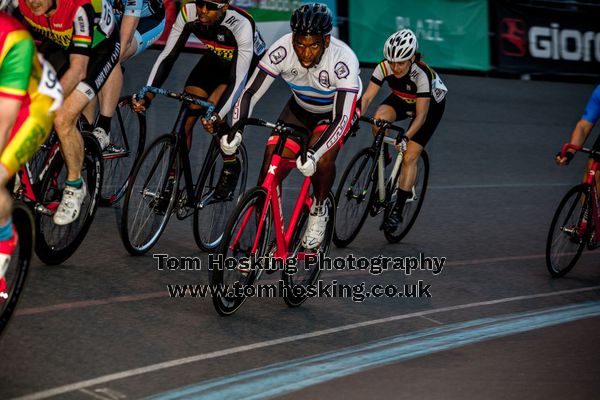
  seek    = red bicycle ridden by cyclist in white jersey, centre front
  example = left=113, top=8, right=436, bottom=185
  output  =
left=211, top=118, right=335, bottom=315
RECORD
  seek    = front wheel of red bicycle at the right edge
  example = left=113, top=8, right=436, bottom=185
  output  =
left=546, top=184, right=593, bottom=278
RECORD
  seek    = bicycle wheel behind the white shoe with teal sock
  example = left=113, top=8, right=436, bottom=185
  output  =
left=35, top=133, right=103, bottom=265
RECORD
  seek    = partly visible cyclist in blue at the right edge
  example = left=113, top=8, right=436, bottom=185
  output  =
left=555, top=85, right=600, bottom=190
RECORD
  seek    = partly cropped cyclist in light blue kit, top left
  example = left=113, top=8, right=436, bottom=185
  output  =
left=86, top=0, right=165, bottom=149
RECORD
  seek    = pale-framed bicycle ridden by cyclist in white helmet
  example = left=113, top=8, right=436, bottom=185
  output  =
left=333, top=116, right=429, bottom=247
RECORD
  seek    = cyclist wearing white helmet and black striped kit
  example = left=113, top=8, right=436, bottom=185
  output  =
left=361, top=29, right=448, bottom=232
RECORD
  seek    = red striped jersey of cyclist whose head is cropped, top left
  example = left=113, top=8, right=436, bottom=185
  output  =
left=19, top=0, right=115, bottom=56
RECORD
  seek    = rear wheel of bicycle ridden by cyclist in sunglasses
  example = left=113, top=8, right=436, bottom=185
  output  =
left=194, top=140, right=248, bottom=251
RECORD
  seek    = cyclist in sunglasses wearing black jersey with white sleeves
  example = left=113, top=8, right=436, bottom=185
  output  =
left=133, top=0, right=265, bottom=199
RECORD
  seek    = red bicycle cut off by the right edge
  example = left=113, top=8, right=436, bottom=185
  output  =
left=546, top=144, right=600, bottom=278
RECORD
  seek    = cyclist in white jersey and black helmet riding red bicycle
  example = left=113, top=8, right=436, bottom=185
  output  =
left=221, top=3, right=362, bottom=249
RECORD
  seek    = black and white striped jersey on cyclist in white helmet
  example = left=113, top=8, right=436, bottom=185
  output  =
left=371, top=60, right=448, bottom=105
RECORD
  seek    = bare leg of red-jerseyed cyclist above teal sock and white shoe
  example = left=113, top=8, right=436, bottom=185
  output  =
left=54, top=90, right=89, bottom=181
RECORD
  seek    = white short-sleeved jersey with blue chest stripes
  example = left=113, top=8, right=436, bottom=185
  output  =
left=258, top=33, right=362, bottom=113
